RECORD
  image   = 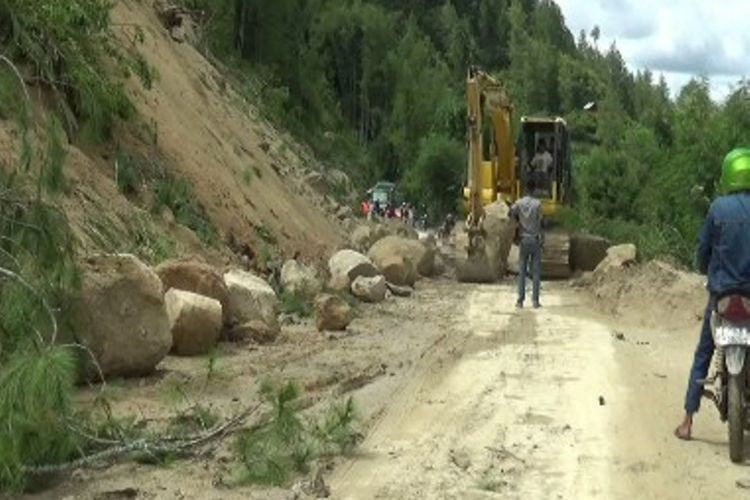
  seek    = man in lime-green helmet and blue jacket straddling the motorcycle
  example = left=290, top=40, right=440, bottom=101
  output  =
left=675, top=148, right=750, bottom=440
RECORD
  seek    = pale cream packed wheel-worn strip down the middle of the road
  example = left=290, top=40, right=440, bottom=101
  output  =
left=331, top=287, right=616, bottom=499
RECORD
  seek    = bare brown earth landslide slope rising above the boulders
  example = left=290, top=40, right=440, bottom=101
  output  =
left=0, top=0, right=342, bottom=264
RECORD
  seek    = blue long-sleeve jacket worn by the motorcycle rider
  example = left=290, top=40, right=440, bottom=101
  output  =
left=697, top=192, right=750, bottom=294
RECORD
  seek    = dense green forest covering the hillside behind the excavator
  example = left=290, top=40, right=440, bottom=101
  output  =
left=195, top=0, right=750, bottom=264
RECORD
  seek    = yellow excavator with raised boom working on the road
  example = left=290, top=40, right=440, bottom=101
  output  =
left=462, top=68, right=571, bottom=281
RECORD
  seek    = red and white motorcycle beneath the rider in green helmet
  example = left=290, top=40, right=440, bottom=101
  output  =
left=704, top=292, right=750, bottom=462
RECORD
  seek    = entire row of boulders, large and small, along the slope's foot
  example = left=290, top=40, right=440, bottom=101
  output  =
left=73, top=221, right=439, bottom=377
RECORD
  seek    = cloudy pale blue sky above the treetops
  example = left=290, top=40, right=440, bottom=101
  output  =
left=556, top=0, right=750, bottom=100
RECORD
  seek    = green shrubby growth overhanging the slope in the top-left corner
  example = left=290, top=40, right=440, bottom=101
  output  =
left=0, top=0, right=153, bottom=142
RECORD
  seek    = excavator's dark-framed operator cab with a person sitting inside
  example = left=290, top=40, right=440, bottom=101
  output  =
left=516, top=117, right=571, bottom=218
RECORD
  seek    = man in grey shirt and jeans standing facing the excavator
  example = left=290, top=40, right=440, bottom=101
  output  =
left=510, top=177, right=544, bottom=309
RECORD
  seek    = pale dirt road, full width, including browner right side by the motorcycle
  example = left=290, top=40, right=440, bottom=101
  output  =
left=330, top=285, right=750, bottom=500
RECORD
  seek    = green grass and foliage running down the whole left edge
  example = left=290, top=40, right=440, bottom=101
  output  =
left=0, top=0, right=156, bottom=490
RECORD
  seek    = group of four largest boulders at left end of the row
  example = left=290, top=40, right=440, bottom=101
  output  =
left=74, top=254, right=280, bottom=377
